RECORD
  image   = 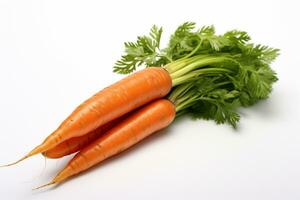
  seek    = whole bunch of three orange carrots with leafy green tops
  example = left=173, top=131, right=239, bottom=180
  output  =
left=2, top=22, right=278, bottom=187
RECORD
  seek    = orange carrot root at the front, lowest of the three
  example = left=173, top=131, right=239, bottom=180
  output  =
left=36, top=99, right=176, bottom=189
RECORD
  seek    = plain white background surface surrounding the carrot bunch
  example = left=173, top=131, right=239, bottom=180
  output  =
left=0, top=0, right=300, bottom=200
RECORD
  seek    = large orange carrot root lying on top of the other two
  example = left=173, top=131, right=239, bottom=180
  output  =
left=3, top=67, right=172, bottom=166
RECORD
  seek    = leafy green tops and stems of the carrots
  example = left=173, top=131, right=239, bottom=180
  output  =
left=114, top=22, right=279, bottom=127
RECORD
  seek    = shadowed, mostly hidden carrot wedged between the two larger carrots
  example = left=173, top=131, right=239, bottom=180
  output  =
left=42, top=113, right=129, bottom=158
